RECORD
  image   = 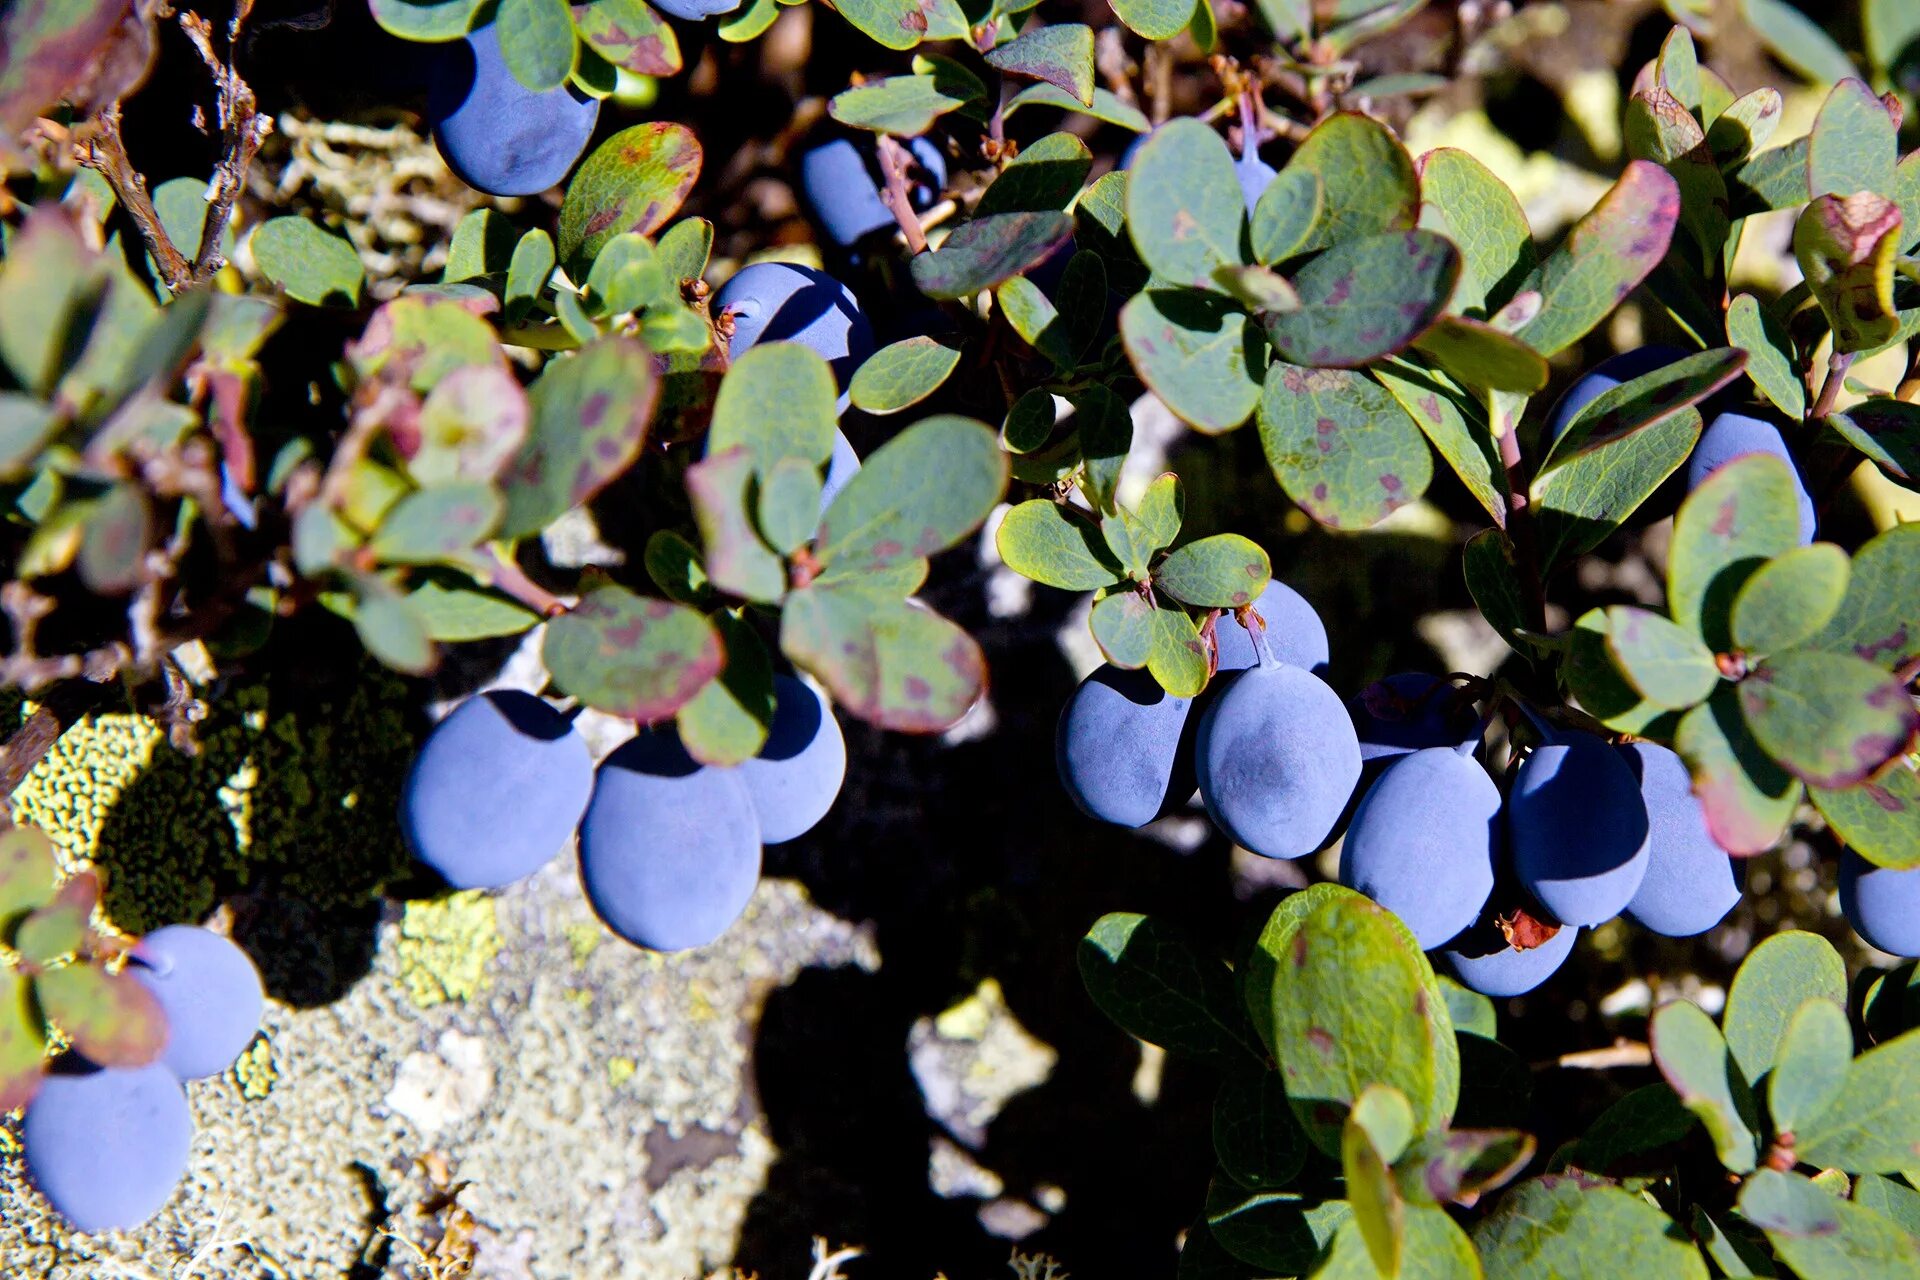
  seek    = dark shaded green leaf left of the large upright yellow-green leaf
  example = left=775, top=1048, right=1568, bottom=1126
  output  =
left=1079, top=912, right=1252, bottom=1061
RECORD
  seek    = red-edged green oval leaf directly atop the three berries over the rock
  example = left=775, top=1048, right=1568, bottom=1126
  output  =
left=540, top=585, right=724, bottom=723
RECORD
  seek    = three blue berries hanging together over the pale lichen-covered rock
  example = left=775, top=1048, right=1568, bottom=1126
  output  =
left=399, top=676, right=847, bottom=952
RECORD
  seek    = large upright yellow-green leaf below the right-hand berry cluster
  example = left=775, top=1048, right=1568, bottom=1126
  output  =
left=1271, top=892, right=1444, bottom=1153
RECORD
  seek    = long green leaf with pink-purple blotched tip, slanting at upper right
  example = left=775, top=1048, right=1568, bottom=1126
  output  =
left=1517, top=159, right=1680, bottom=355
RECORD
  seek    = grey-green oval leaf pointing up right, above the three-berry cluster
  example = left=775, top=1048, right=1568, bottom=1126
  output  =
left=816, top=415, right=1008, bottom=574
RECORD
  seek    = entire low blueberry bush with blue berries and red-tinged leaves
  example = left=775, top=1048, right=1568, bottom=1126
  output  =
left=0, top=0, right=1920, bottom=1280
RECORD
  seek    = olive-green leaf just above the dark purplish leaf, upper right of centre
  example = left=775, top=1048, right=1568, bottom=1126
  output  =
left=1282, top=111, right=1420, bottom=257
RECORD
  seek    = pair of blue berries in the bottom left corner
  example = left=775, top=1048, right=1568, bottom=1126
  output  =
left=19, top=925, right=265, bottom=1232
